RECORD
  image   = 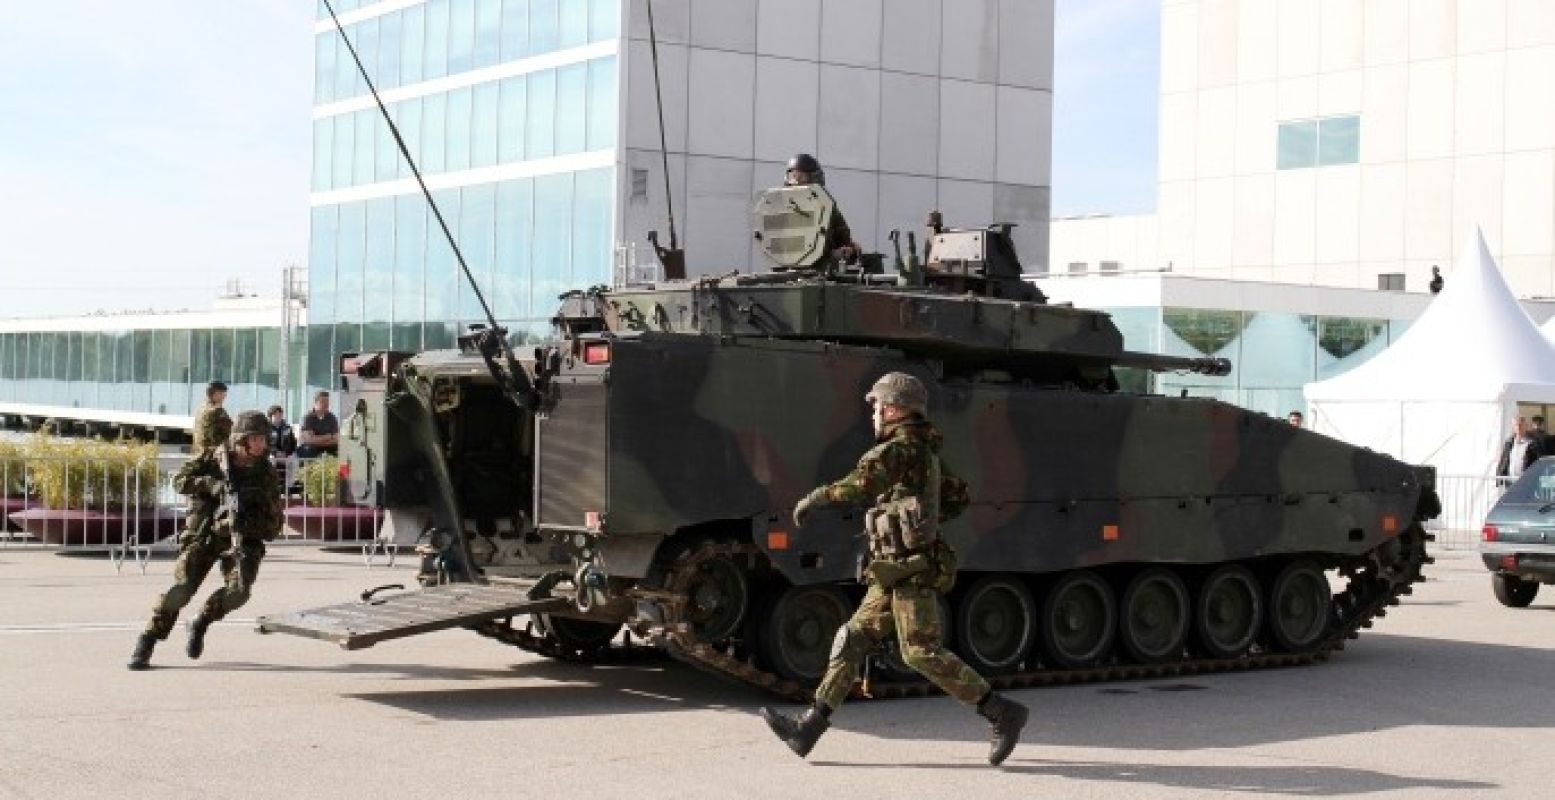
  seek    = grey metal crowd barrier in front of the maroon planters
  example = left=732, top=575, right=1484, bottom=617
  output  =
left=0, top=453, right=395, bottom=571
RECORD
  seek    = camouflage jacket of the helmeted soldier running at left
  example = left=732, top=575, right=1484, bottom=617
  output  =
left=173, top=448, right=281, bottom=540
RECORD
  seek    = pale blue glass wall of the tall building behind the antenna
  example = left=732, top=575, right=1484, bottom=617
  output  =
left=305, top=0, right=620, bottom=389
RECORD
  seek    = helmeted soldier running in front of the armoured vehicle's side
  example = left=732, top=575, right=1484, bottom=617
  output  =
left=762, top=372, right=1026, bottom=766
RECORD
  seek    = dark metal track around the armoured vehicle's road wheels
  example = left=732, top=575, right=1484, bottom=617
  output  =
left=639, top=523, right=1434, bottom=702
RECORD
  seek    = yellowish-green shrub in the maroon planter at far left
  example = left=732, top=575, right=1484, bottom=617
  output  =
left=22, top=433, right=159, bottom=511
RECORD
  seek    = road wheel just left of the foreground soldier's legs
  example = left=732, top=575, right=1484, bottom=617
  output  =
left=759, top=585, right=849, bottom=683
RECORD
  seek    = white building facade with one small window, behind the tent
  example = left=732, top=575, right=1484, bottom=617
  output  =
left=1051, top=0, right=1555, bottom=296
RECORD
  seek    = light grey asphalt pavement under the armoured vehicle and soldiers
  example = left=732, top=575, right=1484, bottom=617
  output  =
left=0, top=538, right=1555, bottom=800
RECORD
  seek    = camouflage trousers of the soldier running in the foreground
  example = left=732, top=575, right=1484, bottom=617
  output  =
left=815, top=581, right=989, bottom=711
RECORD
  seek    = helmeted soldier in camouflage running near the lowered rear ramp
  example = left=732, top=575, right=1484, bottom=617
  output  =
left=129, top=411, right=281, bottom=669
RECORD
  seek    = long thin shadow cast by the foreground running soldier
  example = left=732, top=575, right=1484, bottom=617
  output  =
left=812, top=758, right=1499, bottom=797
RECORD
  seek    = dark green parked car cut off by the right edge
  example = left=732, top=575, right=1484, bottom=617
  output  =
left=1479, top=456, right=1555, bottom=609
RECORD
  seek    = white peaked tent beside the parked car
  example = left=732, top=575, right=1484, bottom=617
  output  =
left=1305, top=232, right=1555, bottom=485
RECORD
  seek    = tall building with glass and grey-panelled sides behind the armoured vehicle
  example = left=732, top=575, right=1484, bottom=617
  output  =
left=306, top=0, right=1053, bottom=392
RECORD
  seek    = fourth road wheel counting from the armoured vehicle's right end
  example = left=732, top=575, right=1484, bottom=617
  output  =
left=1040, top=570, right=1118, bottom=669
